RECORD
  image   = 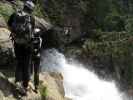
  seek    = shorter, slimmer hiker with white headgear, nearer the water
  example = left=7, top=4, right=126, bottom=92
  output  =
left=32, top=28, right=42, bottom=93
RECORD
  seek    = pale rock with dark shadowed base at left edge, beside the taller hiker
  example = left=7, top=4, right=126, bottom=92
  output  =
left=0, top=28, right=14, bottom=68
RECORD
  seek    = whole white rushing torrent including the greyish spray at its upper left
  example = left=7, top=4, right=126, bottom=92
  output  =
left=41, top=50, right=122, bottom=100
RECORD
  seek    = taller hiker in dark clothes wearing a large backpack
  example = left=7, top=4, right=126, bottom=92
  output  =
left=8, top=1, right=35, bottom=95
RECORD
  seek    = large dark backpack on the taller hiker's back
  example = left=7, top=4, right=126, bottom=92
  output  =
left=11, top=11, right=32, bottom=45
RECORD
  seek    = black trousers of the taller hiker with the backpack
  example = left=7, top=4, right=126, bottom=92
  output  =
left=14, top=44, right=31, bottom=87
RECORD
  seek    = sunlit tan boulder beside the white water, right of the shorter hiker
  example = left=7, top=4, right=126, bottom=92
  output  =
left=40, top=72, right=65, bottom=100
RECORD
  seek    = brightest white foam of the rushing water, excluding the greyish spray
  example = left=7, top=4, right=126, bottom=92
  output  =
left=63, top=64, right=122, bottom=100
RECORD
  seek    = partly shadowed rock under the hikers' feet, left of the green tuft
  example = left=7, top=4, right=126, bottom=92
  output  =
left=0, top=72, right=41, bottom=100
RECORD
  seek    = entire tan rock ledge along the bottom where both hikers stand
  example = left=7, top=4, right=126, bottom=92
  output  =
left=0, top=72, right=65, bottom=100
